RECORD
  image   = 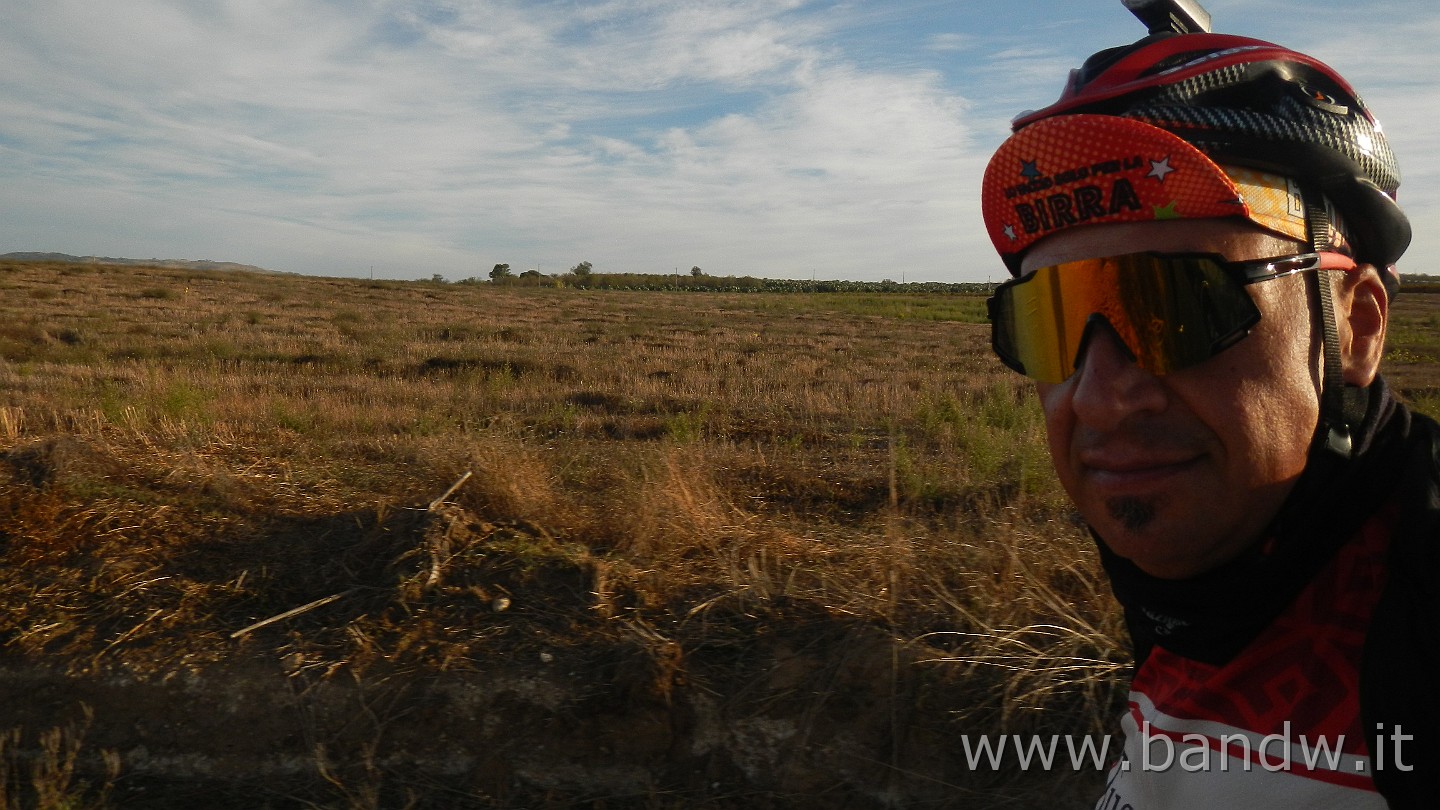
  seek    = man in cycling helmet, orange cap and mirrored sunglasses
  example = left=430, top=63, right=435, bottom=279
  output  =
left=982, top=9, right=1440, bottom=810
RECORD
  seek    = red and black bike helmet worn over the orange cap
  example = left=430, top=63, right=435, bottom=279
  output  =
left=1014, top=32, right=1410, bottom=275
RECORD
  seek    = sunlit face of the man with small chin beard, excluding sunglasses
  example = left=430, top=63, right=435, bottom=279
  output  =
left=1025, top=221, right=1320, bottom=578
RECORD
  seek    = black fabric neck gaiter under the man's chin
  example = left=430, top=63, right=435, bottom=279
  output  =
left=1096, top=379, right=1408, bottom=666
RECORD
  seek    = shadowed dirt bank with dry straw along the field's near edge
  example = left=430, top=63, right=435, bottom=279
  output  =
left=0, top=490, right=1087, bottom=809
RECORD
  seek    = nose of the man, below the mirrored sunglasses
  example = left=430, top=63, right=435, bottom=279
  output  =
left=1071, top=317, right=1166, bottom=430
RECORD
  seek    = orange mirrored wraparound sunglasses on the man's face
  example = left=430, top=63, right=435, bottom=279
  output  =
left=988, top=252, right=1356, bottom=382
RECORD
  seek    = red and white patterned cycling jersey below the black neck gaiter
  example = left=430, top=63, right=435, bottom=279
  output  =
left=1096, top=507, right=1394, bottom=810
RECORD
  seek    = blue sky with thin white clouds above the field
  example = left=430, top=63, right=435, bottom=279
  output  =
left=0, top=0, right=1440, bottom=282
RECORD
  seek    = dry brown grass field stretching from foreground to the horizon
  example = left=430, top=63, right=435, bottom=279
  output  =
left=8, top=256, right=1440, bottom=809
